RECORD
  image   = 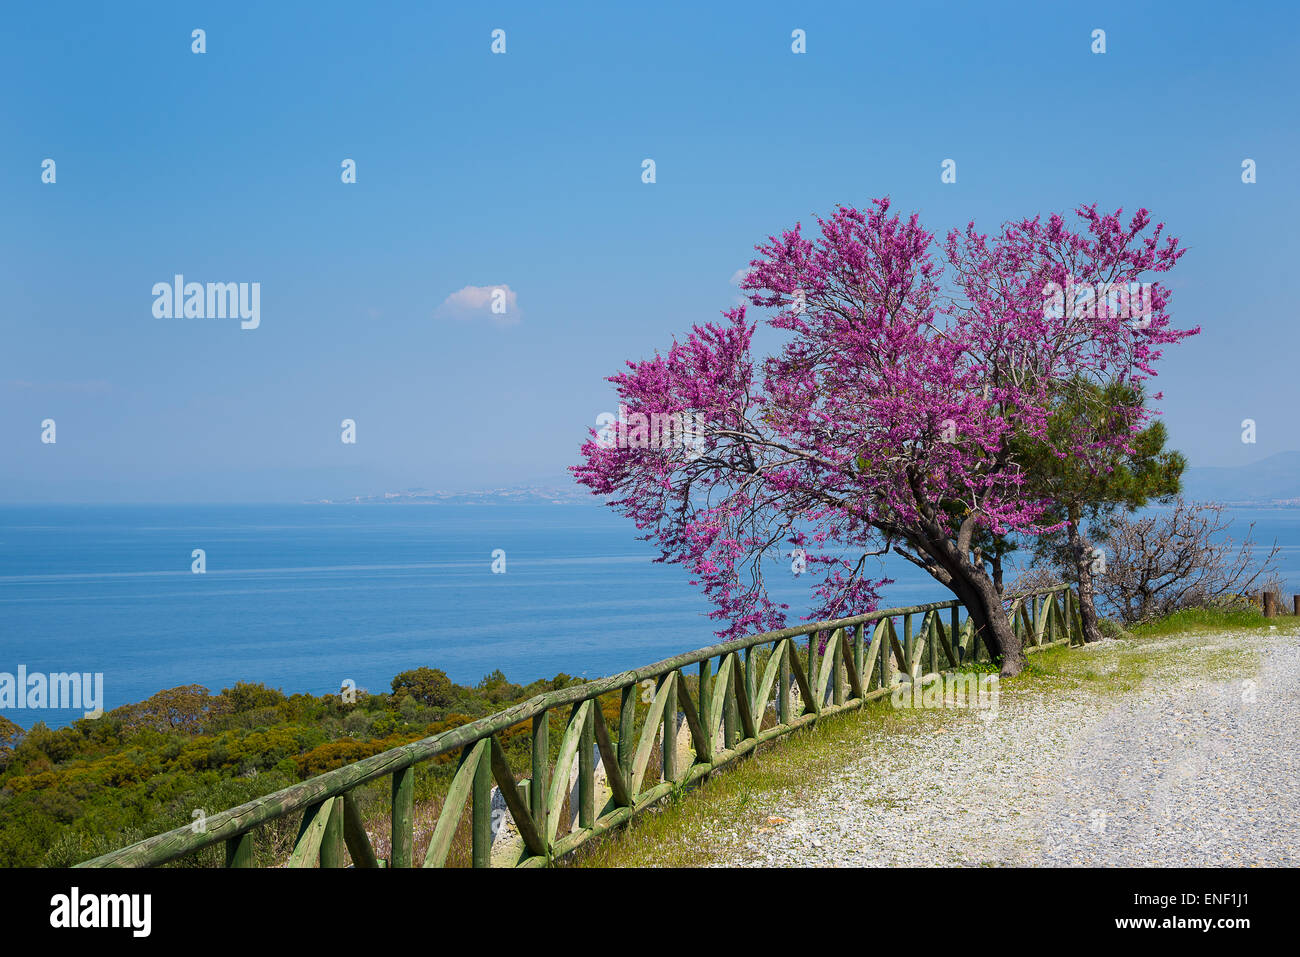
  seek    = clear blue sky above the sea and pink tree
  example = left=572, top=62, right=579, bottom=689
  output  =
left=0, top=3, right=1300, bottom=502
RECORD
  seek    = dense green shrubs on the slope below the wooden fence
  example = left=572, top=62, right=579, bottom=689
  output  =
left=0, top=667, right=576, bottom=867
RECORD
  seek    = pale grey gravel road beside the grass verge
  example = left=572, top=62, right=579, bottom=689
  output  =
left=714, top=631, right=1300, bottom=867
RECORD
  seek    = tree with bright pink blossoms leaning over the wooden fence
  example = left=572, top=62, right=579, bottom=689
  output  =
left=573, top=200, right=1195, bottom=675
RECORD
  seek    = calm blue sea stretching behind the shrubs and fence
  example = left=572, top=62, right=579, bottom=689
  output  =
left=0, top=505, right=1300, bottom=727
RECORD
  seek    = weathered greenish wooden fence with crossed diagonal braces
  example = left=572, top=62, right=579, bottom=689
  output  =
left=78, top=585, right=1083, bottom=867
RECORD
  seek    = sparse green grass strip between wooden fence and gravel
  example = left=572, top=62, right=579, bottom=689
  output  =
left=560, top=609, right=1300, bottom=867
